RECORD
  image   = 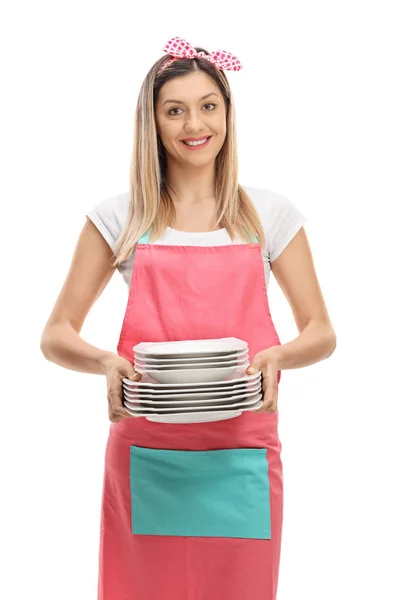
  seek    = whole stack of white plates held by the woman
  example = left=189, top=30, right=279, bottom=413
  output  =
left=123, top=338, right=262, bottom=423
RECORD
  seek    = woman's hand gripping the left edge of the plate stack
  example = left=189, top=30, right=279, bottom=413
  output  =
left=102, top=353, right=142, bottom=423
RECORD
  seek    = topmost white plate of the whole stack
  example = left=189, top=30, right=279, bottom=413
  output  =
left=132, top=337, right=248, bottom=358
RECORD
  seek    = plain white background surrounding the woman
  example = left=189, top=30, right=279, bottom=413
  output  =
left=0, top=0, right=400, bottom=600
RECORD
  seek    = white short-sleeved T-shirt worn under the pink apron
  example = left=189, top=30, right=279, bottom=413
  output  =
left=86, top=185, right=307, bottom=288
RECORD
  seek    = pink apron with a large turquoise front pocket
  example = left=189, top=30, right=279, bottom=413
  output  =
left=98, top=234, right=283, bottom=600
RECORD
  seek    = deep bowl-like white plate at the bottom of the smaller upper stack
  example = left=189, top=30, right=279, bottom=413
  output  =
left=136, top=363, right=250, bottom=383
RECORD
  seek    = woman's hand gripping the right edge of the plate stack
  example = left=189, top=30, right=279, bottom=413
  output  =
left=246, top=348, right=279, bottom=413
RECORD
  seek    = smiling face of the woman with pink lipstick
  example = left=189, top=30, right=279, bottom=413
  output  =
left=155, top=71, right=226, bottom=166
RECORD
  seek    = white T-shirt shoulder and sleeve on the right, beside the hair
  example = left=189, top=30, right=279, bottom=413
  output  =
left=242, top=185, right=307, bottom=262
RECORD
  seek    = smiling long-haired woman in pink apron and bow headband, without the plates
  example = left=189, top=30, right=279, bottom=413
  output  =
left=41, top=38, right=336, bottom=600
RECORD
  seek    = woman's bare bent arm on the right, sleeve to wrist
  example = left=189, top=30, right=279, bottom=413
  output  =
left=269, top=227, right=336, bottom=370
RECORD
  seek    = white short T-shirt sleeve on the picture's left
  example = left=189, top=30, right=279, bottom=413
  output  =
left=86, top=193, right=129, bottom=252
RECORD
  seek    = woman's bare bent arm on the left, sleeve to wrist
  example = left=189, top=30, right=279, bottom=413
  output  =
left=40, top=219, right=122, bottom=374
